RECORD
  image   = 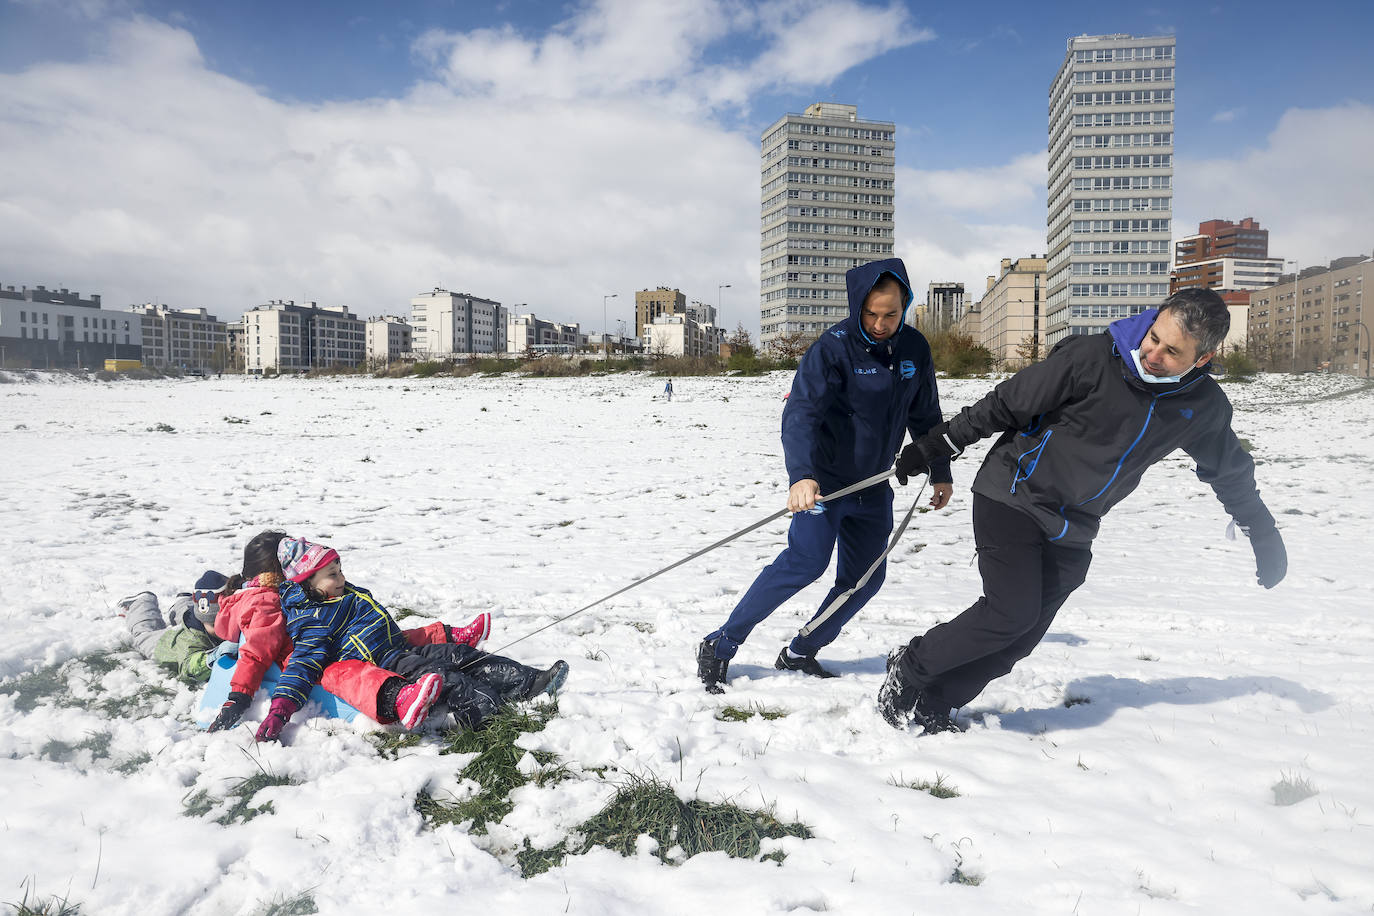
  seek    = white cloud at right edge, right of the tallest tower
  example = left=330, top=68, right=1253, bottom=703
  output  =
left=1173, top=102, right=1374, bottom=265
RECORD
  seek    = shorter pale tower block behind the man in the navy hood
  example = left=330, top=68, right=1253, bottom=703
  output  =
left=758, top=102, right=896, bottom=349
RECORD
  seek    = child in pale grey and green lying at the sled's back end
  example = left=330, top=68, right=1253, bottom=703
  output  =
left=118, top=570, right=235, bottom=683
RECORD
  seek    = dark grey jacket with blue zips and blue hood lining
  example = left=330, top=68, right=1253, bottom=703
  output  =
left=948, top=309, right=1274, bottom=545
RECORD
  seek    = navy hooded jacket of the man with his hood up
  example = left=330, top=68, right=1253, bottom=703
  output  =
left=782, top=258, right=954, bottom=493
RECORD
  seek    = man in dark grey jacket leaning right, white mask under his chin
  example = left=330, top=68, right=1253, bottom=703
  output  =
left=878, top=288, right=1287, bottom=733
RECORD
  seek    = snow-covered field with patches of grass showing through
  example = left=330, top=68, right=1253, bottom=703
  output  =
left=0, top=374, right=1374, bottom=915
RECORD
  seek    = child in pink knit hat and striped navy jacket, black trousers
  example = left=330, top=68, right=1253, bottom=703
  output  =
left=257, top=537, right=567, bottom=740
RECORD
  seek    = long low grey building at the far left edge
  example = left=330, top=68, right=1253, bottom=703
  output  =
left=0, top=286, right=143, bottom=369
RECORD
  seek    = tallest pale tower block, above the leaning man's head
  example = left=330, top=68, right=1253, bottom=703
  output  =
left=1044, top=34, right=1175, bottom=346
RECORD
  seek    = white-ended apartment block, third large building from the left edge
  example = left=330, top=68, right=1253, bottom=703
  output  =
left=243, top=299, right=367, bottom=375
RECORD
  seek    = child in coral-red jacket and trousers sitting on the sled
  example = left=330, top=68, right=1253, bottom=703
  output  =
left=209, top=531, right=492, bottom=737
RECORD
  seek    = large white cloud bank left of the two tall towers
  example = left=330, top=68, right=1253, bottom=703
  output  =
left=0, top=0, right=922, bottom=330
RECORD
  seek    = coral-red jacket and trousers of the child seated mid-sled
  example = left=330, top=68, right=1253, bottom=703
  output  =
left=214, top=578, right=449, bottom=722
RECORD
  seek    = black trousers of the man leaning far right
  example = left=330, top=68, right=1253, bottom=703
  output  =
left=903, top=493, right=1092, bottom=707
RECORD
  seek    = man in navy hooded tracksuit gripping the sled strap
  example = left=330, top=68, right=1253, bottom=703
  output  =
left=697, top=258, right=954, bottom=694
